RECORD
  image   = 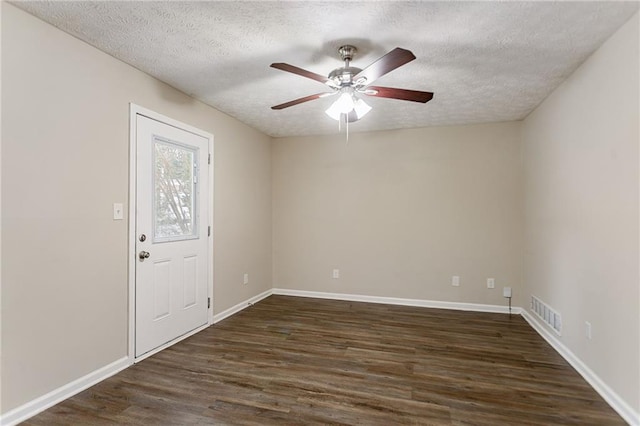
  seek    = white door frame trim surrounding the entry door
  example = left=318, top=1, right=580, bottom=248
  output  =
left=127, top=103, right=214, bottom=364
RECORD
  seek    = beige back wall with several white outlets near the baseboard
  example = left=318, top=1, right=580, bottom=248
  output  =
left=272, top=122, right=522, bottom=305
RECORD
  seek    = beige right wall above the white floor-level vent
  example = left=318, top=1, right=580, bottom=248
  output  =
left=523, top=14, right=640, bottom=412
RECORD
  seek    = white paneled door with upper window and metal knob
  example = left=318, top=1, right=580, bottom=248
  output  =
left=135, top=114, right=210, bottom=357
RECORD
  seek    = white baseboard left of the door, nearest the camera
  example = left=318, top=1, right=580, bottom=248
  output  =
left=0, top=356, right=131, bottom=426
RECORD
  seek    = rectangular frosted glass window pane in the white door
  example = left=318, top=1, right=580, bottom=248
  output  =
left=153, top=136, right=198, bottom=242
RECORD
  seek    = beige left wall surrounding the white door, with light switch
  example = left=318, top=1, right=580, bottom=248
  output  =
left=1, top=2, right=271, bottom=413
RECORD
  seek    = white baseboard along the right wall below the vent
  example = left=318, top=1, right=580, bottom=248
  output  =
left=521, top=309, right=640, bottom=426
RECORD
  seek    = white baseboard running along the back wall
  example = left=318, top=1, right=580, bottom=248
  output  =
left=273, top=288, right=521, bottom=314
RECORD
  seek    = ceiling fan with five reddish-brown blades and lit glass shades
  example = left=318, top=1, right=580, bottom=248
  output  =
left=271, top=45, right=433, bottom=122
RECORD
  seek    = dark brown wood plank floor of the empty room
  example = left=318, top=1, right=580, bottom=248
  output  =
left=25, top=296, right=625, bottom=426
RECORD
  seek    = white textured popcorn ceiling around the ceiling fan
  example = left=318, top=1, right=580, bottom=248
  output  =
left=13, top=1, right=638, bottom=136
